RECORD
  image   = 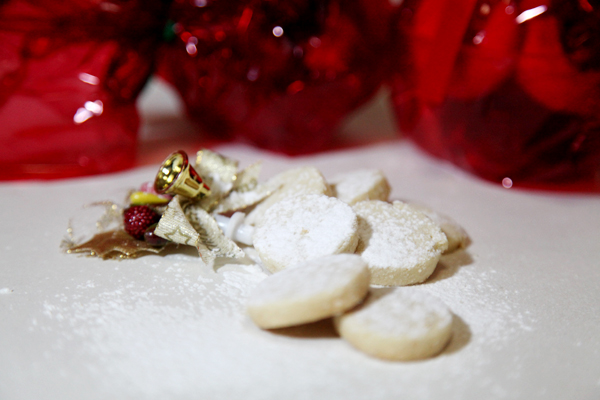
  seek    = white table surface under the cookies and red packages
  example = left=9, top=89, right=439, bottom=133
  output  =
left=0, top=79, right=600, bottom=400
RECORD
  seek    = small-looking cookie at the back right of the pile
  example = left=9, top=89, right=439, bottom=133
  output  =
left=329, top=169, right=390, bottom=205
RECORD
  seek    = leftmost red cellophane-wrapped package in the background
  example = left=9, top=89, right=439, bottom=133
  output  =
left=0, top=0, right=166, bottom=179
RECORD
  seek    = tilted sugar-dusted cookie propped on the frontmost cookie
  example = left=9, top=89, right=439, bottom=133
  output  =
left=247, top=254, right=370, bottom=329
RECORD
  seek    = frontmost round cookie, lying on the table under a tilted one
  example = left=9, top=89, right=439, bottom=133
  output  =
left=334, top=288, right=453, bottom=361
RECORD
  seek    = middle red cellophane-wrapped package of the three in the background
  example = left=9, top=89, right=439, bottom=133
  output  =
left=160, top=0, right=393, bottom=154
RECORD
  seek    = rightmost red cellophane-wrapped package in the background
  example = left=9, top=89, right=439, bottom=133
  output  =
left=393, top=0, right=600, bottom=192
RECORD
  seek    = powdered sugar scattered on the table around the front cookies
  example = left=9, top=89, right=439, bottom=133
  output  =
left=30, top=247, right=533, bottom=399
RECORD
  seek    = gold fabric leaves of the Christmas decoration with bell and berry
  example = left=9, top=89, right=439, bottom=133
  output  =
left=61, top=149, right=277, bottom=265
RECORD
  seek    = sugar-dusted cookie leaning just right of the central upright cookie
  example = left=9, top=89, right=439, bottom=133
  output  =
left=353, top=200, right=448, bottom=286
